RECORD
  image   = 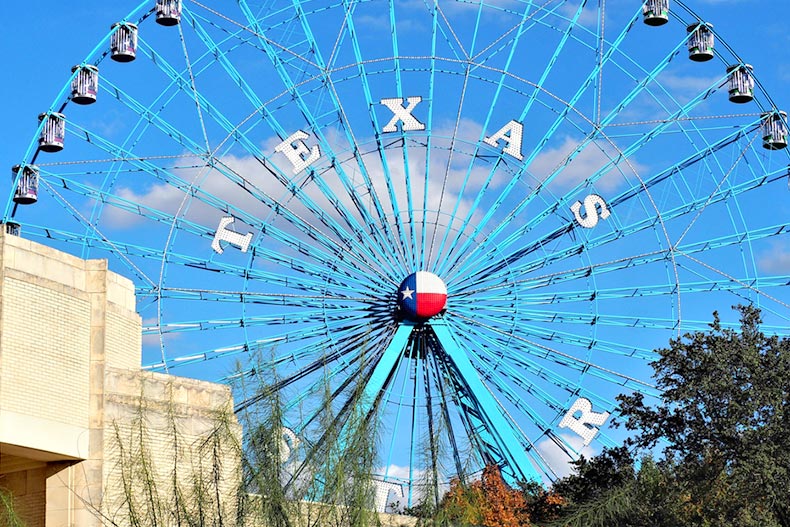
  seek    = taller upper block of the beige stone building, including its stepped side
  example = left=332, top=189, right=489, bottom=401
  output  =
left=0, top=232, right=141, bottom=458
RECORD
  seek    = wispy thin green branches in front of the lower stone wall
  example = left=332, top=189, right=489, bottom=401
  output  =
left=108, top=382, right=240, bottom=527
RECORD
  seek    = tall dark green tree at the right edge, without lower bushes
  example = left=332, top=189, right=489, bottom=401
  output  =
left=619, top=306, right=790, bottom=526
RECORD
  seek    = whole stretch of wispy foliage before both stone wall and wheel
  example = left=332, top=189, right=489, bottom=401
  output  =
left=92, top=350, right=378, bottom=527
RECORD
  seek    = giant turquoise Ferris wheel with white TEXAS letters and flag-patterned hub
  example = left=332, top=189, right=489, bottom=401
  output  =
left=3, top=0, right=790, bottom=506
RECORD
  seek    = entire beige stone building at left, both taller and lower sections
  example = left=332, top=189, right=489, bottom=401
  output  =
left=0, top=232, right=241, bottom=527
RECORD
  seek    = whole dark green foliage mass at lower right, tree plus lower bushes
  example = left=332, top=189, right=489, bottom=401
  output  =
left=552, top=306, right=790, bottom=527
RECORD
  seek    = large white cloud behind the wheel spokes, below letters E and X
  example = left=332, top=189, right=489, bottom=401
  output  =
left=96, top=119, right=524, bottom=262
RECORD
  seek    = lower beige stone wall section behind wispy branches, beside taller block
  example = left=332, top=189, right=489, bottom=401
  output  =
left=102, top=369, right=241, bottom=526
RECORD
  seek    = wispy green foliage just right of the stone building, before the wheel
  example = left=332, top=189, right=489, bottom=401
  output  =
left=237, top=350, right=378, bottom=527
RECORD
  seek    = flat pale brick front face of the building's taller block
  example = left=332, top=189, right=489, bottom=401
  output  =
left=0, top=241, right=90, bottom=457
